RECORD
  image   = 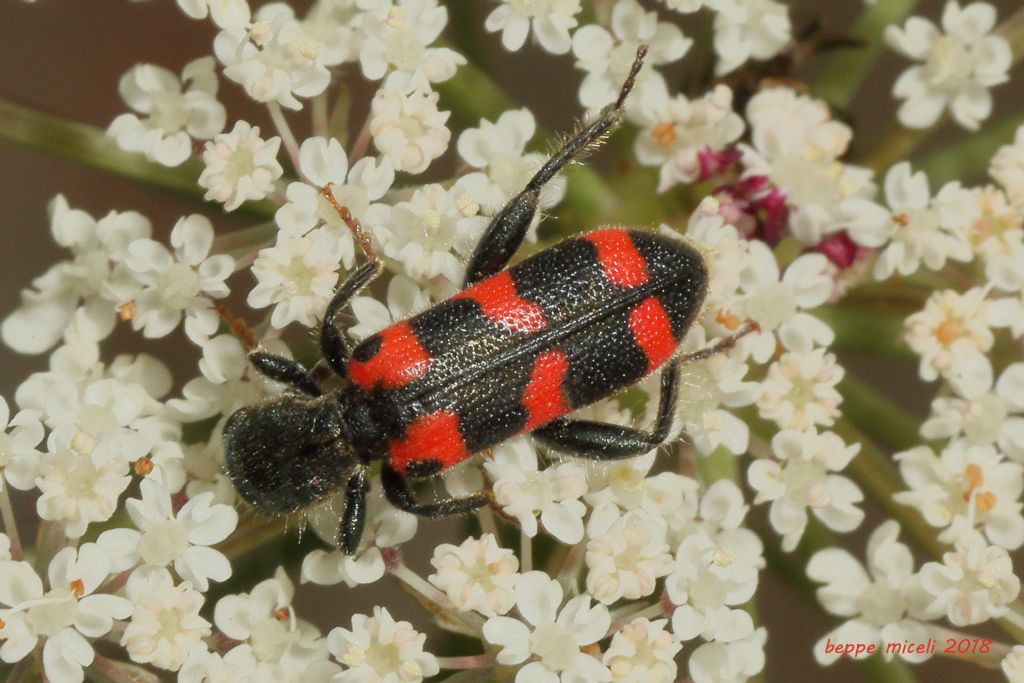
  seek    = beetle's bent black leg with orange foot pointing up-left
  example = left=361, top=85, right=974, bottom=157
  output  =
left=319, top=184, right=384, bottom=377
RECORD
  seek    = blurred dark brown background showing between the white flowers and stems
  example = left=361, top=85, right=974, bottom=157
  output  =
left=0, top=0, right=1024, bottom=682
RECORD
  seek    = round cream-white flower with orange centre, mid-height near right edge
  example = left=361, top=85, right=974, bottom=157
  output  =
left=904, top=287, right=994, bottom=382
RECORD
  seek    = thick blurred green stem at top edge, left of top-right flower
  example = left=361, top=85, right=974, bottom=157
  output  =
left=811, top=0, right=918, bottom=110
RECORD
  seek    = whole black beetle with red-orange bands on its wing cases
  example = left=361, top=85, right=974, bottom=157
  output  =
left=223, top=46, right=746, bottom=554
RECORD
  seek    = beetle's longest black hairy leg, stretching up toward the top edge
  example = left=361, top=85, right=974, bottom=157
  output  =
left=463, top=45, right=647, bottom=288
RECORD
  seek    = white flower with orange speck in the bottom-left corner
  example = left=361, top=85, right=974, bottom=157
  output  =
left=0, top=543, right=131, bottom=683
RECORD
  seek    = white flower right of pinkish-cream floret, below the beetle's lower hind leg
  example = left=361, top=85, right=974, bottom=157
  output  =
left=665, top=525, right=765, bottom=643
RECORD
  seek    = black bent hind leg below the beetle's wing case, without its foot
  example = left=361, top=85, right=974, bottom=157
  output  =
left=531, top=362, right=679, bottom=460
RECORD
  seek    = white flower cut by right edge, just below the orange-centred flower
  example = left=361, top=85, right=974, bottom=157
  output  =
left=921, top=362, right=1024, bottom=462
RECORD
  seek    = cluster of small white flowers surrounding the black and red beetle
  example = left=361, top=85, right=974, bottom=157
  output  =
left=6, top=0, right=1024, bottom=683
